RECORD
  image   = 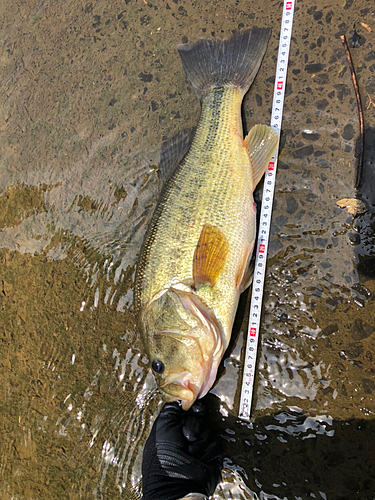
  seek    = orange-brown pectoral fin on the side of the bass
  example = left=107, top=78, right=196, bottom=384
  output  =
left=193, top=224, right=229, bottom=289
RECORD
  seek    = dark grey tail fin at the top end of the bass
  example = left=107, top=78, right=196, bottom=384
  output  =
left=177, top=27, right=271, bottom=99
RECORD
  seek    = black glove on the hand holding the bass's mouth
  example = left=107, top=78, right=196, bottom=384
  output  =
left=142, top=402, right=223, bottom=500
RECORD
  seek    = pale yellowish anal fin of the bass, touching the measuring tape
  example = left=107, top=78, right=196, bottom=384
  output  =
left=244, top=125, right=279, bottom=188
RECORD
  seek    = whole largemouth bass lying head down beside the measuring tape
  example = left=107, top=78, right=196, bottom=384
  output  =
left=135, top=27, right=278, bottom=409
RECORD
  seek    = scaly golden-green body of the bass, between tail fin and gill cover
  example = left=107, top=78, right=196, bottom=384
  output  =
left=136, top=88, right=255, bottom=328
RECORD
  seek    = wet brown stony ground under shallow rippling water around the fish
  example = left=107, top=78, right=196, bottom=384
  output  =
left=0, top=0, right=375, bottom=500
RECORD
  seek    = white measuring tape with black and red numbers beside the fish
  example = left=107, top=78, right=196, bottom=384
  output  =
left=238, top=0, right=295, bottom=420
